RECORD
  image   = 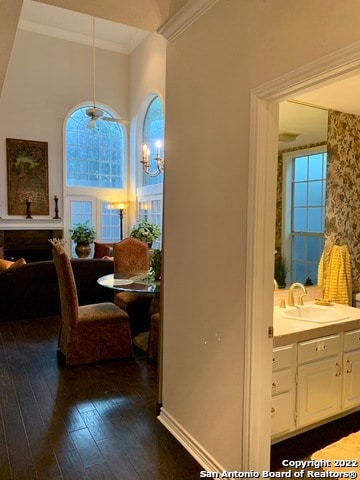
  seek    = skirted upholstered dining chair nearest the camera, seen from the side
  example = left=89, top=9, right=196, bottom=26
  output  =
left=53, top=245, right=132, bottom=365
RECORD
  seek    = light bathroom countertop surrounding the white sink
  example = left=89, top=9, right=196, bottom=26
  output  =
left=273, top=302, right=360, bottom=347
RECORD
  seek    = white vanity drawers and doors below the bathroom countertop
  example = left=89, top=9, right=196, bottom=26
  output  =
left=271, top=325, right=360, bottom=443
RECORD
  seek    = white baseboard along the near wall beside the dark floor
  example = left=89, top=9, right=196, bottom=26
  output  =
left=158, top=407, right=225, bottom=473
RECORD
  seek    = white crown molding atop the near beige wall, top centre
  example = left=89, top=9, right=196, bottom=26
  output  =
left=157, top=0, right=219, bottom=42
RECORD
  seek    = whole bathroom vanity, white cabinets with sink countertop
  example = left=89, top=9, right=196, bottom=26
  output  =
left=271, top=302, right=360, bottom=443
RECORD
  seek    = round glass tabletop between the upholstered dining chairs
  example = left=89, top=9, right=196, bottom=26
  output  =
left=97, top=273, right=160, bottom=293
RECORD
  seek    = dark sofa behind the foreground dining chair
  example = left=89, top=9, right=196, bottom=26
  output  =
left=0, top=258, right=114, bottom=321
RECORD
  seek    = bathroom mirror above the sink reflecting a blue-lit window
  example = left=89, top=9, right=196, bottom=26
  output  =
left=275, top=101, right=328, bottom=286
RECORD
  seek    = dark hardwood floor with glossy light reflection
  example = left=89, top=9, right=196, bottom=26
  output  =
left=0, top=318, right=202, bottom=480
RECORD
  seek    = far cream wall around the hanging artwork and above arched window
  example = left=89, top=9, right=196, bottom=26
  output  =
left=0, top=30, right=129, bottom=226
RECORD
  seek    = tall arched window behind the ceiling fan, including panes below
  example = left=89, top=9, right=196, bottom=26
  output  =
left=64, top=105, right=126, bottom=248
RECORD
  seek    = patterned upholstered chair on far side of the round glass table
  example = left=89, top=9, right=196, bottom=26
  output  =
left=114, top=237, right=154, bottom=337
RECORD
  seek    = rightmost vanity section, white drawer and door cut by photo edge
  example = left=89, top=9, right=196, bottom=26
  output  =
left=342, top=330, right=360, bottom=409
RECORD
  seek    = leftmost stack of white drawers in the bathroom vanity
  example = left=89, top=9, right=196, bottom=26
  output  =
left=271, top=344, right=296, bottom=437
